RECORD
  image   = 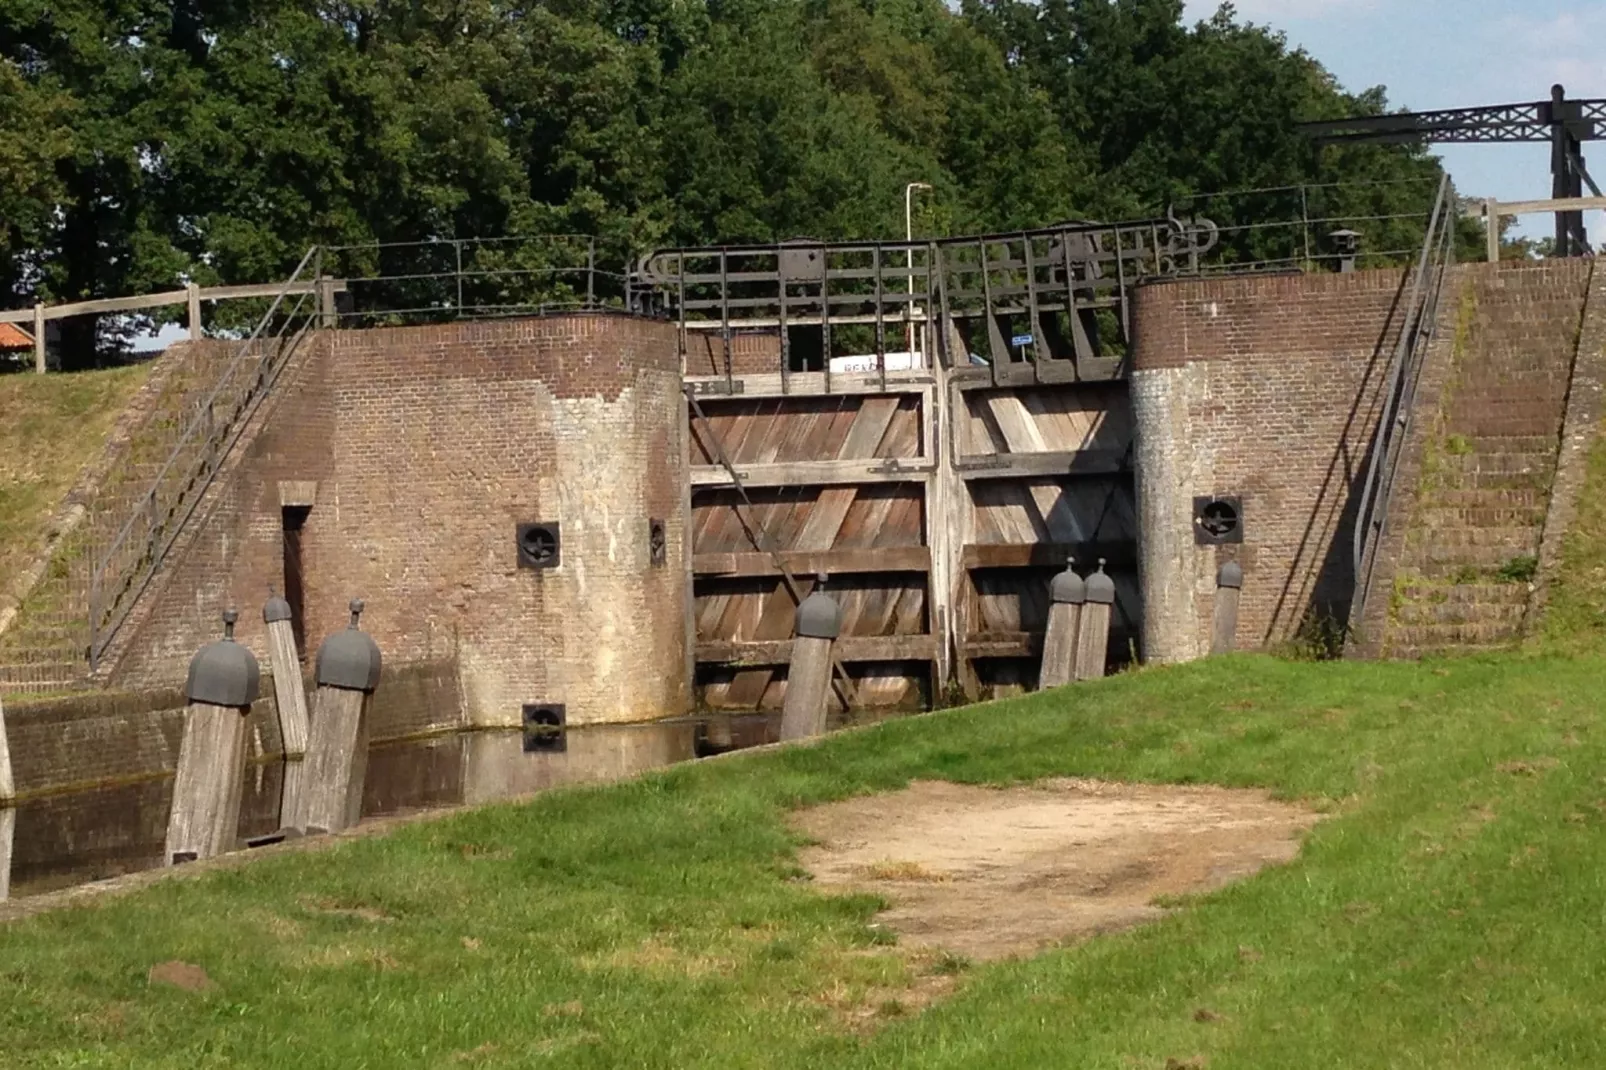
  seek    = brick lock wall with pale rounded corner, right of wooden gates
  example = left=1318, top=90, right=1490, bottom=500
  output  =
left=1132, top=270, right=1404, bottom=662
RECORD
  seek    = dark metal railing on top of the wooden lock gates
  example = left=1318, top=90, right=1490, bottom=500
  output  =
left=634, top=217, right=1216, bottom=387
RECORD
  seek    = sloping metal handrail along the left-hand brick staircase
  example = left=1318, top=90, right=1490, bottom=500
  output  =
left=88, top=247, right=332, bottom=675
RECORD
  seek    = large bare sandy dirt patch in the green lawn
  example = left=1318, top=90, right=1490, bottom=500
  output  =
left=793, top=781, right=1319, bottom=959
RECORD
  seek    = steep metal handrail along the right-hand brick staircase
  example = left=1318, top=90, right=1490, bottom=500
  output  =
left=1349, top=175, right=1458, bottom=631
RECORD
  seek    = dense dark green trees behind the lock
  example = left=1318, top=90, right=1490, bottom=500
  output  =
left=0, top=0, right=1458, bottom=357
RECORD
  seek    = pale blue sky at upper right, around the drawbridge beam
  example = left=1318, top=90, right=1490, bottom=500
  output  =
left=1187, top=0, right=1606, bottom=240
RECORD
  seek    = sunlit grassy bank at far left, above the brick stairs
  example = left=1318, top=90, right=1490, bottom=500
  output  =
left=0, top=361, right=153, bottom=578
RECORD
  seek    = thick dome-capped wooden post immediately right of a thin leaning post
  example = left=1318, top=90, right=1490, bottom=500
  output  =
left=296, top=599, right=379, bottom=832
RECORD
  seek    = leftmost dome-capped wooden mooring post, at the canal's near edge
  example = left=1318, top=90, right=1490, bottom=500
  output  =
left=165, top=609, right=262, bottom=866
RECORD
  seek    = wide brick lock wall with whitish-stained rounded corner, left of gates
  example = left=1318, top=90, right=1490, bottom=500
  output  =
left=117, top=315, right=689, bottom=725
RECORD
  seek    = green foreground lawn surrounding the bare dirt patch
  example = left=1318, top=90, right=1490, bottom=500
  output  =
left=0, top=645, right=1606, bottom=1070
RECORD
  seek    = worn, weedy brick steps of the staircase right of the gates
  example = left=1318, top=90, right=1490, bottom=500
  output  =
left=1381, top=262, right=1590, bottom=657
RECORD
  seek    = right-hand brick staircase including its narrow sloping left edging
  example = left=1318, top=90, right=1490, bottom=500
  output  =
left=1362, top=259, right=1601, bottom=657
